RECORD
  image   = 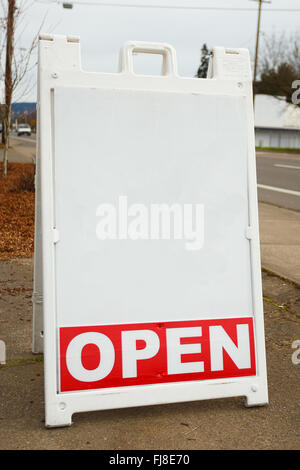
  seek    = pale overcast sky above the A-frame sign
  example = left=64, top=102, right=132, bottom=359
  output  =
left=7, top=0, right=300, bottom=101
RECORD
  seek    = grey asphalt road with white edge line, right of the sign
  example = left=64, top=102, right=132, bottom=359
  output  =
left=256, top=152, right=300, bottom=211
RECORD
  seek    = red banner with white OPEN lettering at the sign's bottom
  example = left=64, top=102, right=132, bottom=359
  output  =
left=59, top=317, right=256, bottom=392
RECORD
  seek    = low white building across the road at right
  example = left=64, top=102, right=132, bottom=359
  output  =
left=255, top=95, right=300, bottom=149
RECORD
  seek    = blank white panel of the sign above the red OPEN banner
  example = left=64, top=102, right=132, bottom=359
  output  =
left=54, top=87, right=253, bottom=327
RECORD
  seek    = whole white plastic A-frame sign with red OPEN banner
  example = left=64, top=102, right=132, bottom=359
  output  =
left=34, top=35, right=268, bottom=427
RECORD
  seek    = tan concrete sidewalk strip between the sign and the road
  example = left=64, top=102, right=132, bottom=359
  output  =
left=259, top=203, right=300, bottom=285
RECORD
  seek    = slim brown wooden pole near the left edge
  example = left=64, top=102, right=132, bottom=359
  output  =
left=3, top=0, right=16, bottom=178
